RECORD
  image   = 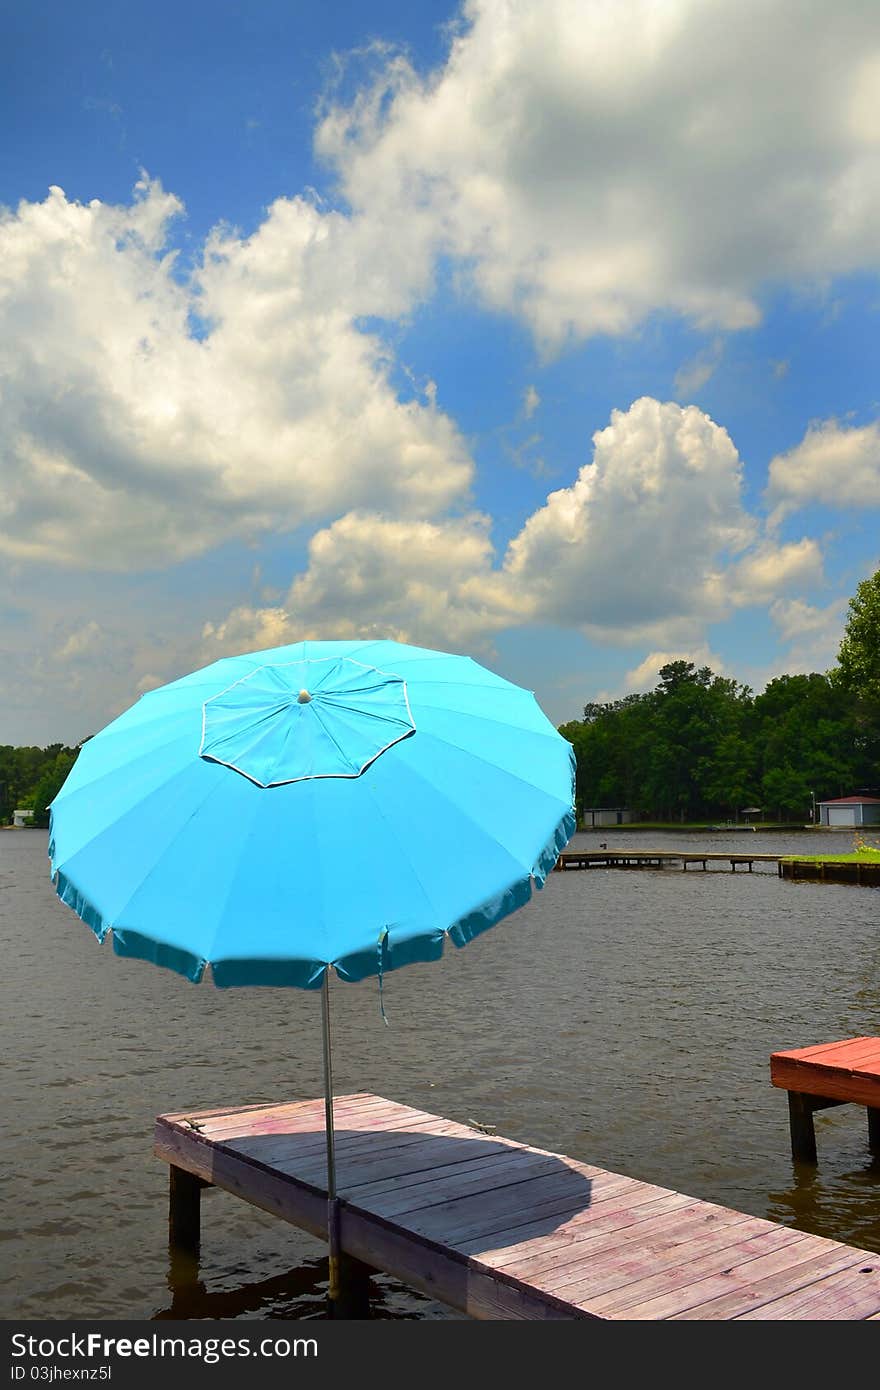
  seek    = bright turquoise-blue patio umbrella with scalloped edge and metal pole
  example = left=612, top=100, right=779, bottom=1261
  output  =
left=49, top=641, right=576, bottom=1300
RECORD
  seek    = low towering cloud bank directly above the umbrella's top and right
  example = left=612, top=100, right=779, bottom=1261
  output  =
left=204, top=398, right=822, bottom=664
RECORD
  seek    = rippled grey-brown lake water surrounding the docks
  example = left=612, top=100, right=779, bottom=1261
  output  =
left=0, top=831, right=880, bottom=1319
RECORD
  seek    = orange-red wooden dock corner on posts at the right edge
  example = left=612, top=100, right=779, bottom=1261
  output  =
left=770, top=1037, right=880, bottom=1163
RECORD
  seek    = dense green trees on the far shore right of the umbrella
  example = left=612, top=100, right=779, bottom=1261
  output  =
left=559, top=570, right=880, bottom=823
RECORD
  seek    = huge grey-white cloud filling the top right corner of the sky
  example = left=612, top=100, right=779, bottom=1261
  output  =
left=317, top=0, right=880, bottom=349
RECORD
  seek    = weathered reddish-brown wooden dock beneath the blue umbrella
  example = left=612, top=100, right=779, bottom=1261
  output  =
left=156, top=1094, right=880, bottom=1321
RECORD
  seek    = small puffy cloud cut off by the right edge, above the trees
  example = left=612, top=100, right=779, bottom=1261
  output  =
left=767, top=420, right=880, bottom=524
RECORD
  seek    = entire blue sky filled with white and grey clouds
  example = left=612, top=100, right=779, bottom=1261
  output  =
left=0, top=0, right=880, bottom=744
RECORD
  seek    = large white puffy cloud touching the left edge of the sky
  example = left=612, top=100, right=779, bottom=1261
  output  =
left=0, top=181, right=471, bottom=570
